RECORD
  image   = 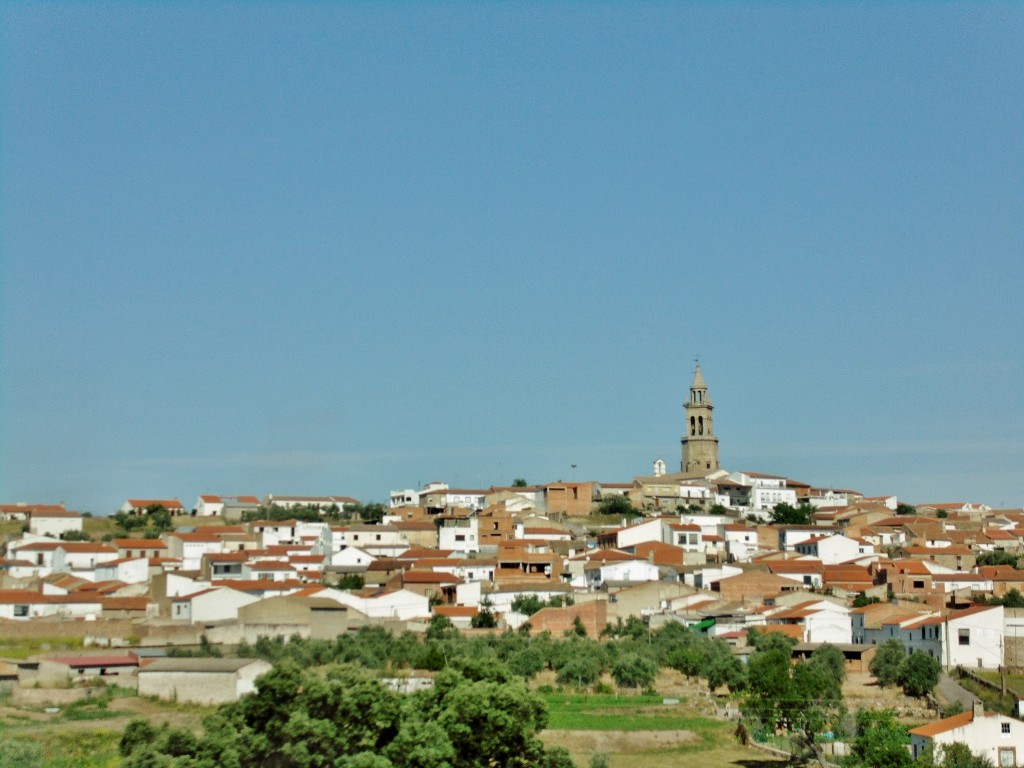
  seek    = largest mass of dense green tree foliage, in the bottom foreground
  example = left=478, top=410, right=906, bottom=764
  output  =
left=121, top=663, right=571, bottom=768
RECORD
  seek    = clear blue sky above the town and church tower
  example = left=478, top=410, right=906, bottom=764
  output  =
left=0, top=2, right=1024, bottom=514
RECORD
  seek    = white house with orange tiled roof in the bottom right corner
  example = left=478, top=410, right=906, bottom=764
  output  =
left=909, top=702, right=1024, bottom=768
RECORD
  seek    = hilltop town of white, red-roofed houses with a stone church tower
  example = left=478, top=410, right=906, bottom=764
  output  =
left=0, top=367, right=1024, bottom=765
